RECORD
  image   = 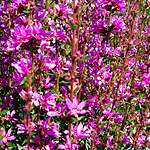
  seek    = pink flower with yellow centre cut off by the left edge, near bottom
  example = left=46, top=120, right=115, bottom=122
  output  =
left=0, top=127, right=16, bottom=144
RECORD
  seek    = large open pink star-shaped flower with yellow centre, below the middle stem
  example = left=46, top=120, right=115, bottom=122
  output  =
left=66, top=97, right=86, bottom=119
